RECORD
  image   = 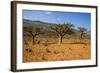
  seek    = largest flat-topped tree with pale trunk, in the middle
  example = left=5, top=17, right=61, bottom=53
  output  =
left=50, top=23, right=73, bottom=44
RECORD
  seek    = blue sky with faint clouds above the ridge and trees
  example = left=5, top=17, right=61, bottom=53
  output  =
left=23, top=10, right=91, bottom=30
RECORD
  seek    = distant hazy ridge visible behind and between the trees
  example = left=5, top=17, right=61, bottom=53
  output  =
left=23, top=19, right=90, bottom=38
